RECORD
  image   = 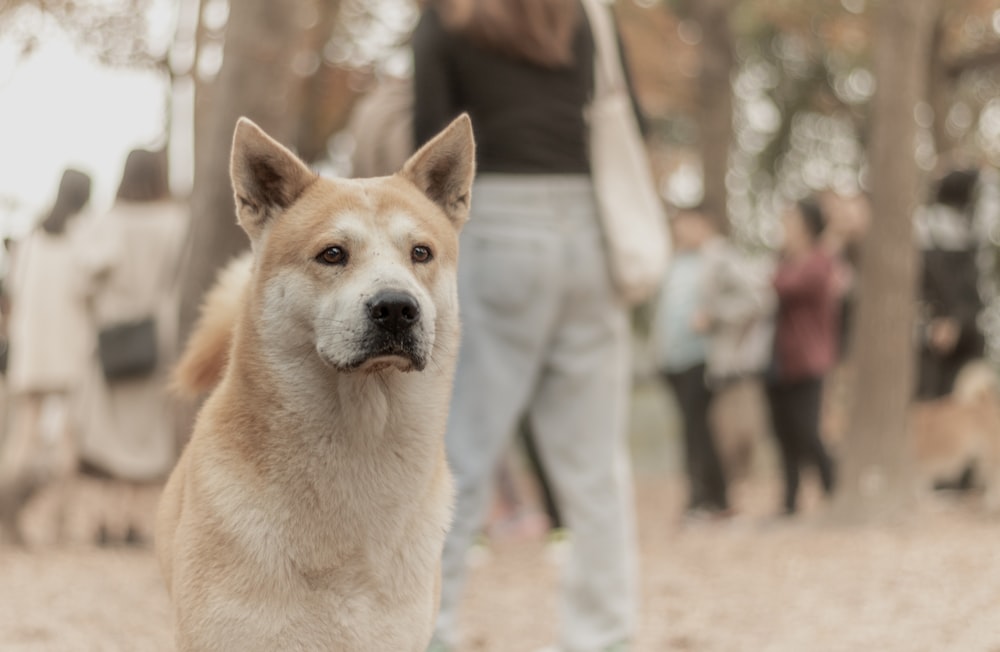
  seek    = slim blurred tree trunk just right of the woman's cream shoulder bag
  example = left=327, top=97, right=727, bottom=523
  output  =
left=691, top=0, right=735, bottom=233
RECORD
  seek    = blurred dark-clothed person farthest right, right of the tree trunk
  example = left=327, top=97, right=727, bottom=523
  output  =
left=917, top=170, right=986, bottom=400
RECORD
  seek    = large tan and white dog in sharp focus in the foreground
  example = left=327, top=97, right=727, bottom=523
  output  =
left=156, top=116, right=474, bottom=652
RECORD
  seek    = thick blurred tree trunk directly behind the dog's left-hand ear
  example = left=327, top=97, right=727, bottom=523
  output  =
left=179, top=0, right=312, bottom=341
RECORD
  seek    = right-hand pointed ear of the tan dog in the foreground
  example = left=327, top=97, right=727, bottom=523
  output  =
left=400, top=113, right=476, bottom=228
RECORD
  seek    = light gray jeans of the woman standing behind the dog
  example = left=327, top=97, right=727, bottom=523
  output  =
left=435, top=174, right=637, bottom=652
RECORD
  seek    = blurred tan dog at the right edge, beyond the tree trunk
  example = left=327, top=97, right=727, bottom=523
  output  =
left=910, top=361, right=1000, bottom=512
